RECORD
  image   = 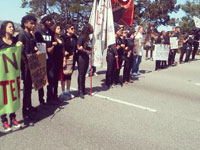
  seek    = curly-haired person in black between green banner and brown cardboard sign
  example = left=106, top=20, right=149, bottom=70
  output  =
left=18, top=15, right=37, bottom=123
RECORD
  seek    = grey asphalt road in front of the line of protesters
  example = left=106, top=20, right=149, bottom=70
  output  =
left=0, top=56, right=200, bottom=150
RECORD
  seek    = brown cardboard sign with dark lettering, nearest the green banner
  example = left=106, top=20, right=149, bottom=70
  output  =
left=27, top=53, right=48, bottom=90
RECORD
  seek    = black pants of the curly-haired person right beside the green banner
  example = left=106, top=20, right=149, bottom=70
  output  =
left=21, top=62, right=32, bottom=114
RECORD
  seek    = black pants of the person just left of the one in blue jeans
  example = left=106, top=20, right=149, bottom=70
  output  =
left=123, top=54, right=133, bottom=82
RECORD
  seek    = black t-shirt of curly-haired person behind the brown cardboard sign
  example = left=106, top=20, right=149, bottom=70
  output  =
left=18, top=30, right=36, bottom=54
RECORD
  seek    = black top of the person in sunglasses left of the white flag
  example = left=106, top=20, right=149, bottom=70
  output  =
left=63, top=35, right=78, bottom=55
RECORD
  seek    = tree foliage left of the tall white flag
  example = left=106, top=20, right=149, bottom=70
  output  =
left=22, top=0, right=93, bottom=28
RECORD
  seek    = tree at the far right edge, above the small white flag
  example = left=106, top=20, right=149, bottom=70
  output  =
left=179, top=0, right=200, bottom=33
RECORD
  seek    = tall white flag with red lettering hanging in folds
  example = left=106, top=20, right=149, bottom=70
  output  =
left=89, top=0, right=115, bottom=67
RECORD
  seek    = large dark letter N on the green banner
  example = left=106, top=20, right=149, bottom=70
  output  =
left=2, top=53, right=19, bottom=73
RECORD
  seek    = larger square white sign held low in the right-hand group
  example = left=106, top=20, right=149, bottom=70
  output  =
left=153, top=44, right=169, bottom=60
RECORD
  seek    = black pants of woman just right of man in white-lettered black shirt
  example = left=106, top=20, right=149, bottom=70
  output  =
left=53, top=58, right=63, bottom=98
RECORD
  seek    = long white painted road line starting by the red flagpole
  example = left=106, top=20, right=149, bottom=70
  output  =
left=68, top=88, right=157, bottom=112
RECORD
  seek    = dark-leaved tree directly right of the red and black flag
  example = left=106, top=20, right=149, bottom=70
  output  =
left=134, top=0, right=180, bottom=26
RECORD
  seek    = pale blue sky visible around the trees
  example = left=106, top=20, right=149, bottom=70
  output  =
left=0, top=0, right=192, bottom=31
